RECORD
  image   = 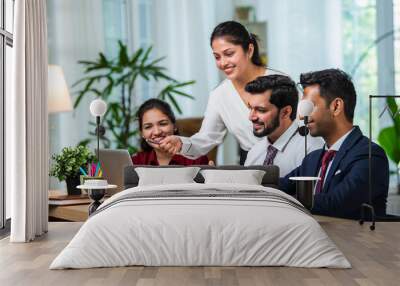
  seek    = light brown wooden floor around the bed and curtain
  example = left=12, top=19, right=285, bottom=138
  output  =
left=0, top=220, right=400, bottom=286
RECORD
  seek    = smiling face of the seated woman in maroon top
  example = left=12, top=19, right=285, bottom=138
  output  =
left=140, top=108, right=175, bottom=149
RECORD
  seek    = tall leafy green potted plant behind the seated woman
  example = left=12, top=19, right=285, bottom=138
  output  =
left=74, top=41, right=194, bottom=153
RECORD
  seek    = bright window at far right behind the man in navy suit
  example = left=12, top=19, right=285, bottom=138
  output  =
left=342, top=0, right=400, bottom=198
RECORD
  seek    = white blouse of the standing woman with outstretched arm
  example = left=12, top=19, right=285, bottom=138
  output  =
left=180, top=69, right=280, bottom=158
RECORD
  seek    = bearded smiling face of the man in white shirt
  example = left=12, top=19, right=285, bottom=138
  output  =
left=248, top=90, right=280, bottom=137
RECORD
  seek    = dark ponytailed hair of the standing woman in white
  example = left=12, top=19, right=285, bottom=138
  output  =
left=210, top=21, right=264, bottom=66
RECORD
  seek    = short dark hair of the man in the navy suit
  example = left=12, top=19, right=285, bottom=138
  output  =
left=300, top=69, right=357, bottom=122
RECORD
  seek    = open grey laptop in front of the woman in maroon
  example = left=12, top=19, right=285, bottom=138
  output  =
left=99, top=149, right=133, bottom=195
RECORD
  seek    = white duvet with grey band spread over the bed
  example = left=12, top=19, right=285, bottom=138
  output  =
left=50, top=184, right=351, bottom=269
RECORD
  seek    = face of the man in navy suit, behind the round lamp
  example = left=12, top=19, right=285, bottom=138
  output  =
left=303, top=84, right=335, bottom=138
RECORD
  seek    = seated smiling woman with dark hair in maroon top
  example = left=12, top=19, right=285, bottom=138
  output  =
left=132, top=98, right=208, bottom=166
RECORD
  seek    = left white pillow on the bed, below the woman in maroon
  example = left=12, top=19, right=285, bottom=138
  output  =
left=135, top=167, right=200, bottom=186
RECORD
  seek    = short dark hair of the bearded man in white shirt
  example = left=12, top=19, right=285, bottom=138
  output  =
left=245, top=74, right=299, bottom=121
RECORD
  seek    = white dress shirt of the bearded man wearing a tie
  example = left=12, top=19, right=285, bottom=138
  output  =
left=244, top=121, right=324, bottom=177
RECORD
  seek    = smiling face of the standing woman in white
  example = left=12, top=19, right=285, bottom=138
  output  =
left=211, top=37, right=253, bottom=80
